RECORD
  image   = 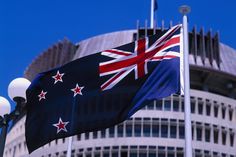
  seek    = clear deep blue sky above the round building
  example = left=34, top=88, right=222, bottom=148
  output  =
left=0, top=0, right=236, bottom=108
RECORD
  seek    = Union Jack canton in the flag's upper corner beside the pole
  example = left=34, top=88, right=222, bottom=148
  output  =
left=99, top=24, right=182, bottom=91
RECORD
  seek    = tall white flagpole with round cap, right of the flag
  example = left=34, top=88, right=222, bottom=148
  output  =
left=179, top=5, right=192, bottom=157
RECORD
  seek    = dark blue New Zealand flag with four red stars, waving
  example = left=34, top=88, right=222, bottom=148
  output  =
left=25, top=25, right=182, bottom=153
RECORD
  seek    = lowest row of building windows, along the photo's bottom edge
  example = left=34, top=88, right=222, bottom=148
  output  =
left=39, top=145, right=236, bottom=157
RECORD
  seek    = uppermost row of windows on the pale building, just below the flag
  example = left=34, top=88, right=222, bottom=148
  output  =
left=143, top=96, right=236, bottom=121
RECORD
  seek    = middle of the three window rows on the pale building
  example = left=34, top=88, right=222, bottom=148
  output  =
left=77, top=118, right=235, bottom=147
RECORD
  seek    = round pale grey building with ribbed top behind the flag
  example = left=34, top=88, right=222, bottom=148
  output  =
left=4, top=22, right=236, bottom=157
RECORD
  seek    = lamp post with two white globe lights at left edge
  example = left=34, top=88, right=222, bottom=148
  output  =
left=0, top=78, right=30, bottom=156
